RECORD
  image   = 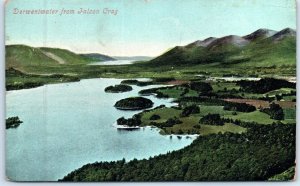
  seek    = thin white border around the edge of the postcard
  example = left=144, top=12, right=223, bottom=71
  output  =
left=0, top=0, right=300, bottom=186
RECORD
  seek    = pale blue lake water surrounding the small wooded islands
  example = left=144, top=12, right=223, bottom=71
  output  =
left=6, top=79, right=194, bottom=181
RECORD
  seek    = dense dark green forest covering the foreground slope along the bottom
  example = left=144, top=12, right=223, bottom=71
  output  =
left=59, top=124, right=296, bottom=181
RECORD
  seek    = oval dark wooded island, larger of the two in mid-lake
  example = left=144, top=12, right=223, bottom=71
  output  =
left=115, top=97, right=153, bottom=110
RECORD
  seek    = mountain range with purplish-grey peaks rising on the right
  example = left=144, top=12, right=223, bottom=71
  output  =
left=147, top=28, right=296, bottom=67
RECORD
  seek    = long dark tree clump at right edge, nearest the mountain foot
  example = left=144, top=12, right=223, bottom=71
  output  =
left=237, top=78, right=296, bottom=94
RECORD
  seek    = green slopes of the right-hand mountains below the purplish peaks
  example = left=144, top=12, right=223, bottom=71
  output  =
left=147, top=34, right=296, bottom=69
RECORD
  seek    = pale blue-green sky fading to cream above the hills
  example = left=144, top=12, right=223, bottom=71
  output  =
left=5, top=0, right=296, bottom=56
